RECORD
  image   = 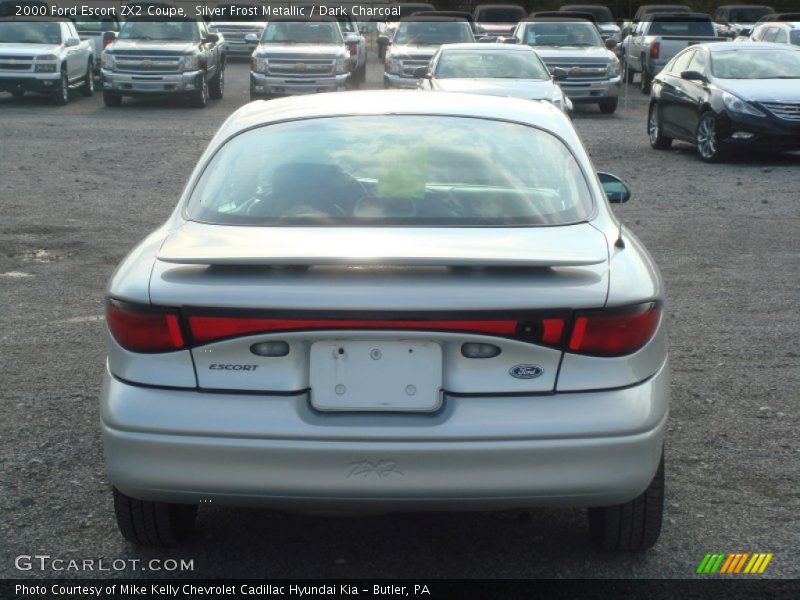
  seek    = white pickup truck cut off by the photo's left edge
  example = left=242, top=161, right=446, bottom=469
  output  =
left=0, top=17, right=95, bottom=104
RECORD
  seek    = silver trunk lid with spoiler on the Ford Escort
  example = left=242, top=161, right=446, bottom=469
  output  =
left=150, top=222, right=608, bottom=398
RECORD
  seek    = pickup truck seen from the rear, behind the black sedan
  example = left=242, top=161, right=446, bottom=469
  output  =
left=619, top=13, right=720, bottom=94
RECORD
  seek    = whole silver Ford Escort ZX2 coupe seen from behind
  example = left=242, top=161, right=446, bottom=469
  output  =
left=101, top=91, right=669, bottom=550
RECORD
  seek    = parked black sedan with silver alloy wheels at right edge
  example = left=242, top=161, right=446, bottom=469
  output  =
left=647, top=42, right=800, bottom=162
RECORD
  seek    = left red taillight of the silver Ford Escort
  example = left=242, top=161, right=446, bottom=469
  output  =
left=106, top=300, right=185, bottom=352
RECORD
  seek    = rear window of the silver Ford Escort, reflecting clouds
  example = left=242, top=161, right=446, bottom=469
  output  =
left=187, top=115, right=592, bottom=227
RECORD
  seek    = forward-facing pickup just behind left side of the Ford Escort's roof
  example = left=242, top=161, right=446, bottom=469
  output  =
left=247, top=17, right=350, bottom=100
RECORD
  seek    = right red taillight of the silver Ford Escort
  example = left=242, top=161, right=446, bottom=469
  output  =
left=567, top=302, right=661, bottom=356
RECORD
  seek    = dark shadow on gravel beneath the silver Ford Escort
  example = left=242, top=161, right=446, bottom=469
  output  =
left=126, top=507, right=649, bottom=578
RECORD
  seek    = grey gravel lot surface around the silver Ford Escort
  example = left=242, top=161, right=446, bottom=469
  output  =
left=0, top=58, right=800, bottom=578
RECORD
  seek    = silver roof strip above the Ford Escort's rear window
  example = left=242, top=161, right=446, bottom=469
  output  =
left=215, top=90, right=568, bottom=145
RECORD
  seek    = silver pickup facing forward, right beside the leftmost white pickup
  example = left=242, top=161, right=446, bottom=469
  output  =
left=100, top=19, right=225, bottom=108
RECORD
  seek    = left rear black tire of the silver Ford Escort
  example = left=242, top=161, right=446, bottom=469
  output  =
left=114, top=488, right=197, bottom=546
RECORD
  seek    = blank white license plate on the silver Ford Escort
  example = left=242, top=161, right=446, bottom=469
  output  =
left=309, top=340, right=442, bottom=412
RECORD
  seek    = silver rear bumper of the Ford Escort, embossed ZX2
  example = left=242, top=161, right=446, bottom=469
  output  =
left=101, top=363, right=669, bottom=512
